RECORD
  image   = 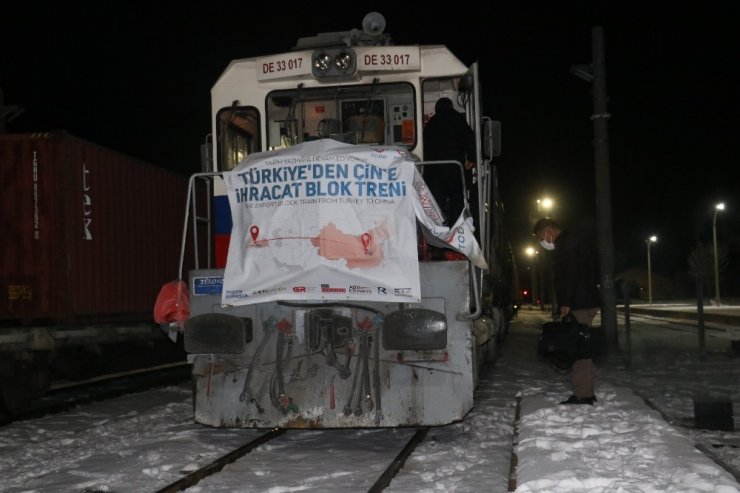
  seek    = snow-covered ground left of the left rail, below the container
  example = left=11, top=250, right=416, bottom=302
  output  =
left=0, top=386, right=258, bottom=493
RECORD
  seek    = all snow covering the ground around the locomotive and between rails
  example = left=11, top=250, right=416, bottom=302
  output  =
left=0, top=310, right=740, bottom=493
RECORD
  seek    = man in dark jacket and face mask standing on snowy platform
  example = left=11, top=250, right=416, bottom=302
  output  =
left=534, top=218, right=601, bottom=405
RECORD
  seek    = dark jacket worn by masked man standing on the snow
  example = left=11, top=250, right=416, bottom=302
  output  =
left=552, top=231, right=601, bottom=310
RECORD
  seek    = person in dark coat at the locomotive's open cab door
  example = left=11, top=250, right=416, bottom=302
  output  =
left=424, top=98, right=475, bottom=226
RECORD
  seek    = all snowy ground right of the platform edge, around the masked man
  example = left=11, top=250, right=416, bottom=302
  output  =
left=504, top=310, right=740, bottom=493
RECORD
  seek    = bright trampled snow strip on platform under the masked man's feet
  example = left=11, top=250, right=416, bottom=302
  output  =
left=516, top=385, right=738, bottom=493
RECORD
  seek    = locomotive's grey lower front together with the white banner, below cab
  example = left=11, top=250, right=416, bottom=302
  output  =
left=185, top=139, right=482, bottom=428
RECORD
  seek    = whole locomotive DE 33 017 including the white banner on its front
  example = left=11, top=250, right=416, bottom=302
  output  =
left=165, top=13, right=516, bottom=428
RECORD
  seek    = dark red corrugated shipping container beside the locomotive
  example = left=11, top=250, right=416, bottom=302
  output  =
left=0, top=133, right=187, bottom=325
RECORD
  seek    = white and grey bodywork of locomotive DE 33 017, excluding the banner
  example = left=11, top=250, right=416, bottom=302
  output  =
left=176, top=14, right=510, bottom=428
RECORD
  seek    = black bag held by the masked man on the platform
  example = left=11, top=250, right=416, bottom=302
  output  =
left=537, top=315, right=593, bottom=366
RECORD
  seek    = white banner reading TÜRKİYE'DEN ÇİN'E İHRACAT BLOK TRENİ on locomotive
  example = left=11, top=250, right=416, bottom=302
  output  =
left=222, top=139, right=485, bottom=306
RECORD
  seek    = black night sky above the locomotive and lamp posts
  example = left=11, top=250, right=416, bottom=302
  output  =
left=0, top=1, right=740, bottom=295
